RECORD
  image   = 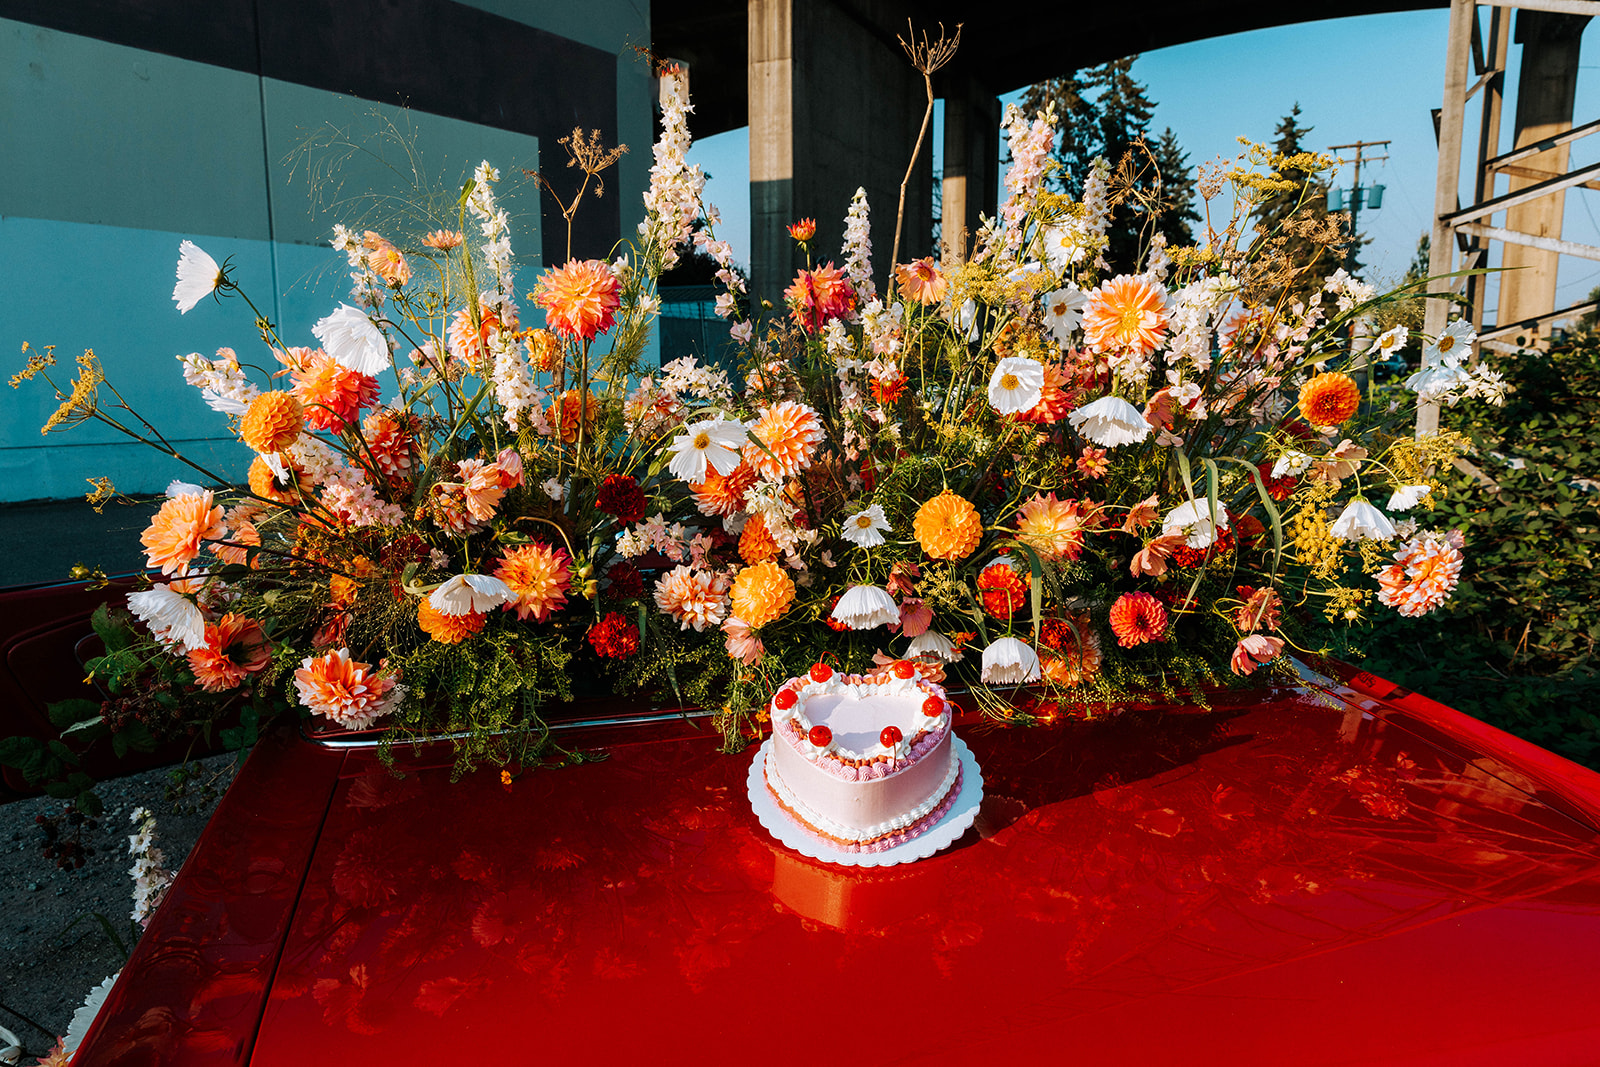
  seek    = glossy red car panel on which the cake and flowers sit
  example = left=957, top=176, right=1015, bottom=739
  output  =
left=75, top=677, right=1600, bottom=1067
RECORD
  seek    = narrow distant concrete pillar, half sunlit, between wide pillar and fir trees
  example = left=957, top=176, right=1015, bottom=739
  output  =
left=939, top=77, right=1000, bottom=262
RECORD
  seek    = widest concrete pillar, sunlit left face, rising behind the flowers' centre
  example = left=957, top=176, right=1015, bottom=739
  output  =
left=749, top=0, right=934, bottom=314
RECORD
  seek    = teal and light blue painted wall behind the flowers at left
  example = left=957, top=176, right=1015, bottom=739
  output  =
left=0, top=2, right=651, bottom=502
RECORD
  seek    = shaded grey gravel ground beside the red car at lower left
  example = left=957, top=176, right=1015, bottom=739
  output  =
left=0, top=755, right=235, bottom=1062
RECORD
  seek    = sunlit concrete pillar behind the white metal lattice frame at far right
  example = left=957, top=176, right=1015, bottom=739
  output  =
left=1498, top=8, right=1589, bottom=336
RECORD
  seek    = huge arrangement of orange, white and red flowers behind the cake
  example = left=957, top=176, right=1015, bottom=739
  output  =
left=13, top=66, right=1499, bottom=766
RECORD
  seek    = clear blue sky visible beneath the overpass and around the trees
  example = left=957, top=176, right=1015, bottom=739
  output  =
left=690, top=10, right=1600, bottom=316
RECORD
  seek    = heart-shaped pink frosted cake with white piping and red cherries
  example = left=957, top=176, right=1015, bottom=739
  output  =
left=766, top=661, right=962, bottom=853
